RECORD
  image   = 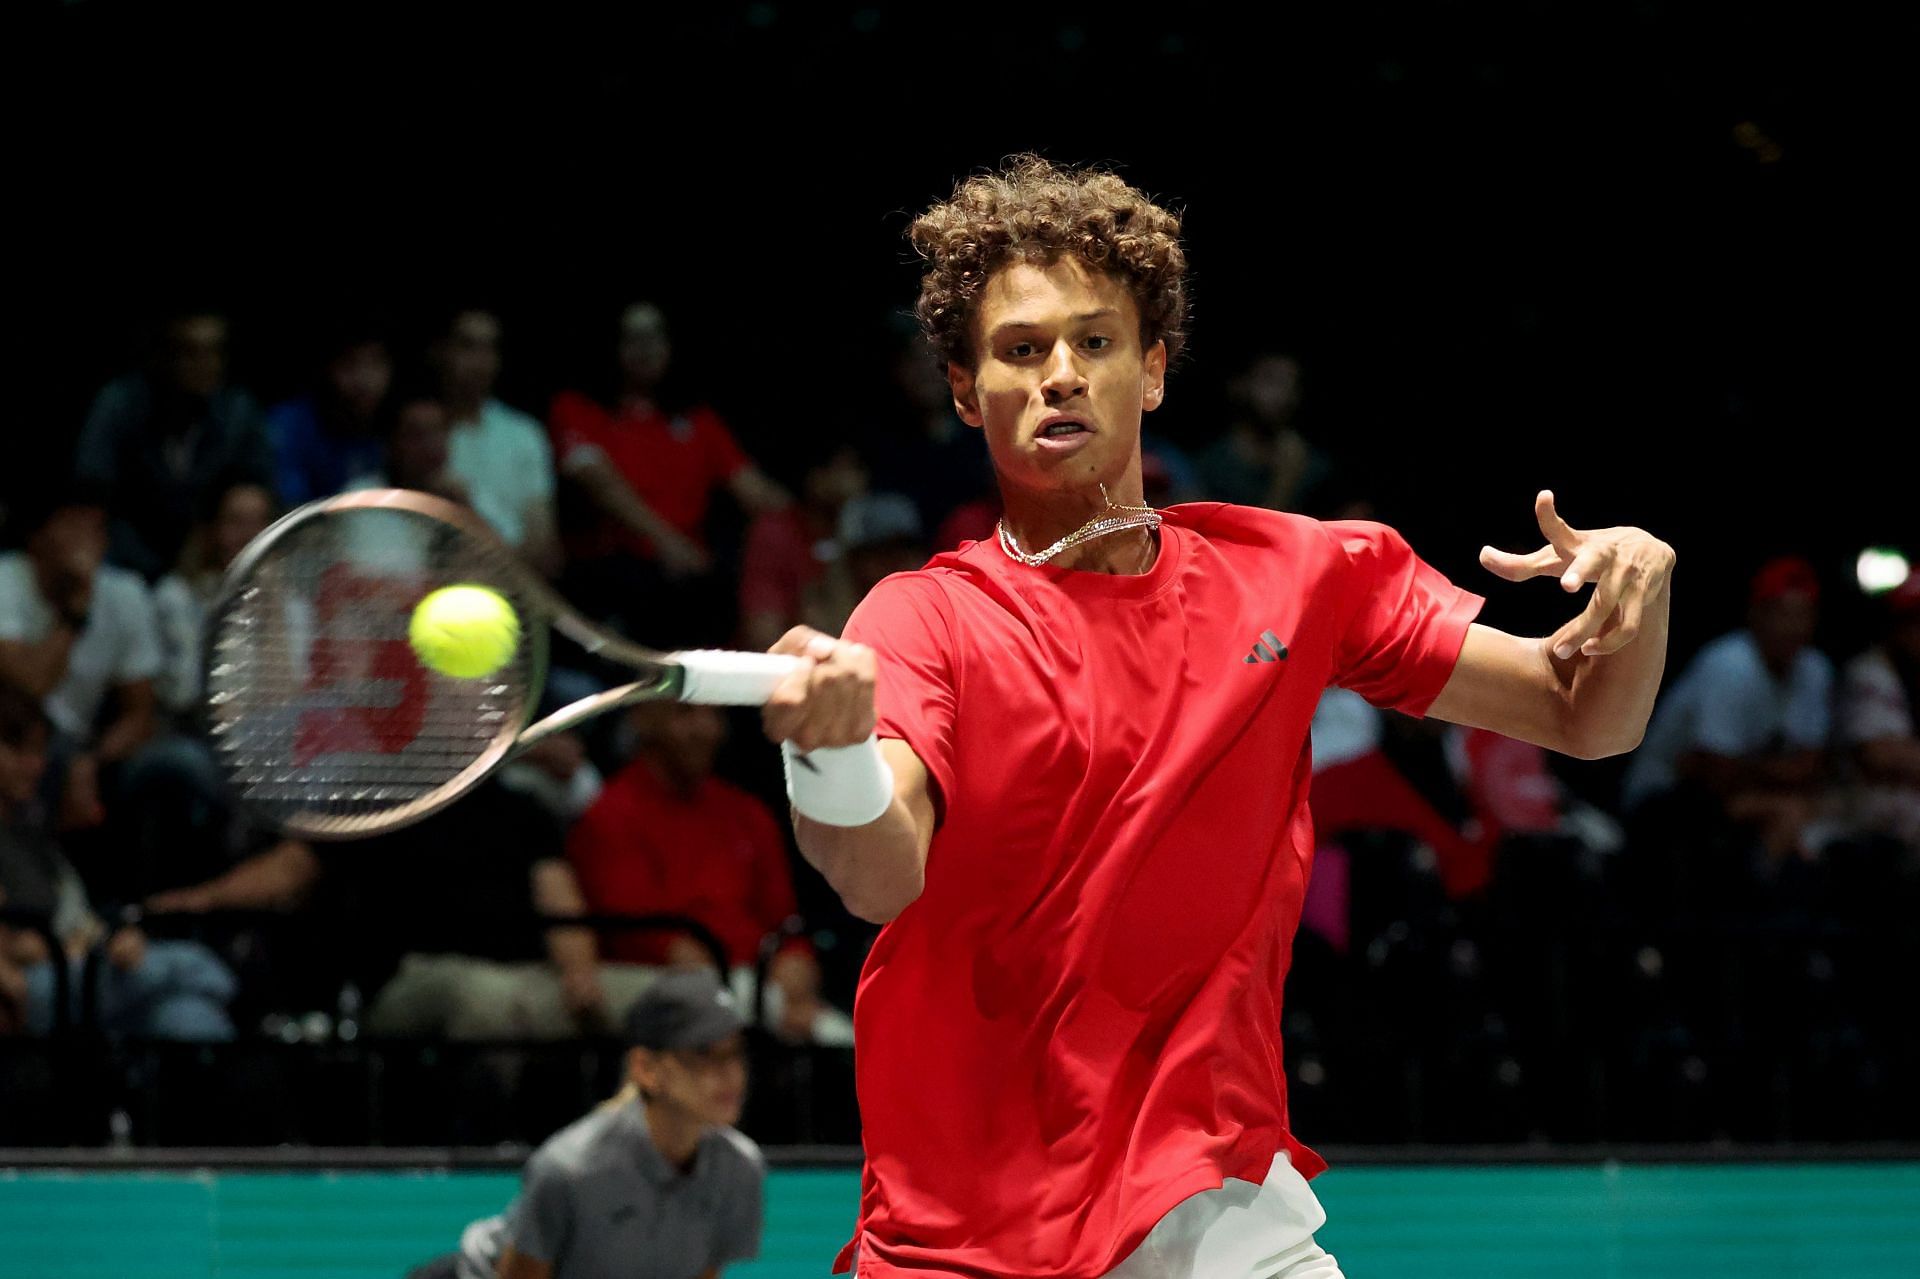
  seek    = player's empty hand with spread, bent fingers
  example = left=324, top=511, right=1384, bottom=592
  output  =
left=1480, top=490, right=1674, bottom=661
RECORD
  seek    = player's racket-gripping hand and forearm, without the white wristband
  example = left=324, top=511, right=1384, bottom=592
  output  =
left=762, top=626, right=933, bottom=924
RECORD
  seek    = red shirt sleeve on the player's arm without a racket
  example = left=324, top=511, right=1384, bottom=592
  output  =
left=1325, top=520, right=1486, bottom=716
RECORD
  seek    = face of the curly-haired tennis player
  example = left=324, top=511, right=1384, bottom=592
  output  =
left=948, top=257, right=1167, bottom=492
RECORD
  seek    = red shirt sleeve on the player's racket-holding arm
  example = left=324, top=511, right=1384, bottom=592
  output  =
left=845, top=572, right=958, bottom=818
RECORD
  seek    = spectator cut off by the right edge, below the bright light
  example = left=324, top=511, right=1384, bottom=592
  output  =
left=1839, top=572, right=1920, bottom=852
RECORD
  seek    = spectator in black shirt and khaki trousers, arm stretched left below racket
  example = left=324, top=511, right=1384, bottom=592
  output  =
left=148, top=782, right=653, bottom=1039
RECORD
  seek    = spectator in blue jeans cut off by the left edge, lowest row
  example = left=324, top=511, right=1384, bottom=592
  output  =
left=0, top=682, right=234, bottom=1043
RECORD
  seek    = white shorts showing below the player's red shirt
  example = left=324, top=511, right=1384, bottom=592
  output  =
left=1106, top=1150, right=1342, bottom=1279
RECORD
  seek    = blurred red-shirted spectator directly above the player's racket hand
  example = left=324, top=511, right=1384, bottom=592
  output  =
left=739, top=444, right=871, bottom=651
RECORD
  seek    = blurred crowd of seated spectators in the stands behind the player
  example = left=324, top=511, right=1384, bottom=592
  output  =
left=0, top=302, right=1920, bottom=1144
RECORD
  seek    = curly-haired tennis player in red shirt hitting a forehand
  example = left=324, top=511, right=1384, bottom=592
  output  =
left=764, top=157, right=1674, bottom=1279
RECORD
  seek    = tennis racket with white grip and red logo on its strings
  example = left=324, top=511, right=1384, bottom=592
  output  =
left=205, top=490, right=799, bottom=839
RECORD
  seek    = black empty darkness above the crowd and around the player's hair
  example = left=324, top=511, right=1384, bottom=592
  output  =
left=41, top=0, right=1920, bottom=657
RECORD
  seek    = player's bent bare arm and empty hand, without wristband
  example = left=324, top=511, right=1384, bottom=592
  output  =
left=1428, top=492, right=1674, bottom=759
